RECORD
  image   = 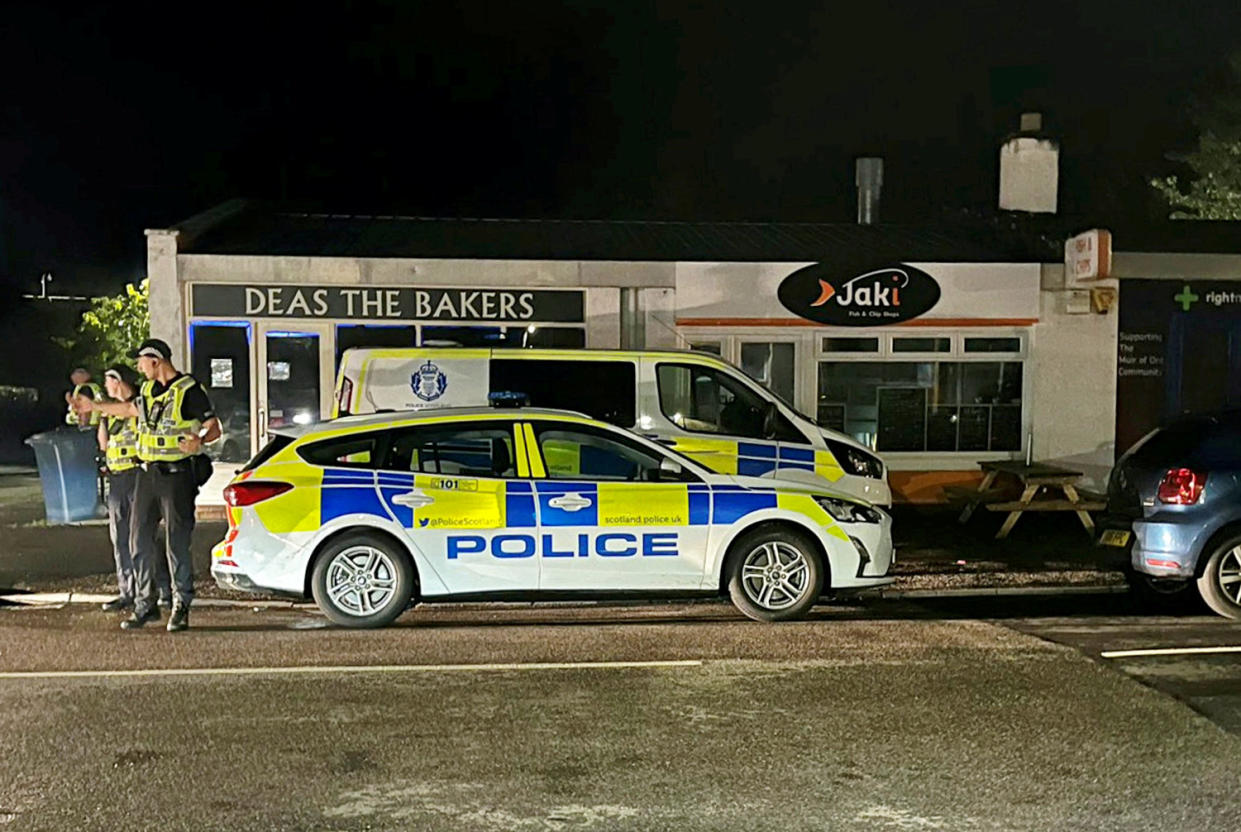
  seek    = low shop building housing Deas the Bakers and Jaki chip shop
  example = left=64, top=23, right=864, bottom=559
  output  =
left=146, top=202, right=1136, bottom=500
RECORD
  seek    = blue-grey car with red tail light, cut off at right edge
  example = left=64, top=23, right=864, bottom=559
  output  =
left=1100, top=411, right=1241, bottom=618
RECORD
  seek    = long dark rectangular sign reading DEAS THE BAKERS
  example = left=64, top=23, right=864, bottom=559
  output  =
left=190, top=283, right=585, bottom=323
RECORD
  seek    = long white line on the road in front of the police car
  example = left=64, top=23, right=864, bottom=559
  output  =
left=0, top=659, right=702, bottom=679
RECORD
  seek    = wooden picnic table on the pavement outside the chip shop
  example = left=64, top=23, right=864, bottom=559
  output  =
left=959, top=459, right=1106, bottom=540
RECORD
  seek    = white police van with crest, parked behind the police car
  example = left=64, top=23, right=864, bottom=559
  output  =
left=333, top=348, right=892, bottom=505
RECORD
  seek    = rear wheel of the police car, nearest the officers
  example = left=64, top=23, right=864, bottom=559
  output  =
left=310, top=534, right=413, bottom=627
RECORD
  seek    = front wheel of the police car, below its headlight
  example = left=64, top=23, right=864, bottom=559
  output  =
left=728, top=529, right=823, bottom=621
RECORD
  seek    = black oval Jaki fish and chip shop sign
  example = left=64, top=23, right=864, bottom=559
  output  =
left=777, top=263, right=939, bottom=327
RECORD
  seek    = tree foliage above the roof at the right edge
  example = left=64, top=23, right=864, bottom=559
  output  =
left=1150, top=52, right=1241, bottom=220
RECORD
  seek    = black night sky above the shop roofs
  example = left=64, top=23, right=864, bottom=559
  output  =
left=0, top=0, right=1241, bottom=296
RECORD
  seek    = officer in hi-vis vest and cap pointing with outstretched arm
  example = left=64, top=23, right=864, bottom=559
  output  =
left=78, top=338, right=220, bottom=632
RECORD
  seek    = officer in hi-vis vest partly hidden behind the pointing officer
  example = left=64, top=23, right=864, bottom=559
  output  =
left=94, top=364, right=172, bottom=612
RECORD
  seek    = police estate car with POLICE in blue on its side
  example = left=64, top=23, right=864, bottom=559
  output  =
left=211, top=407, right=894, bottom=627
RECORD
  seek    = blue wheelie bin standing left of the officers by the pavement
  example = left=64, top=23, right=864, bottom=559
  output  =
left=26, top=427, right=104, bottom=525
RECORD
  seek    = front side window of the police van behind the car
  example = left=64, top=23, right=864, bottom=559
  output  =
left=656, top=364, right=805, bottom=442
